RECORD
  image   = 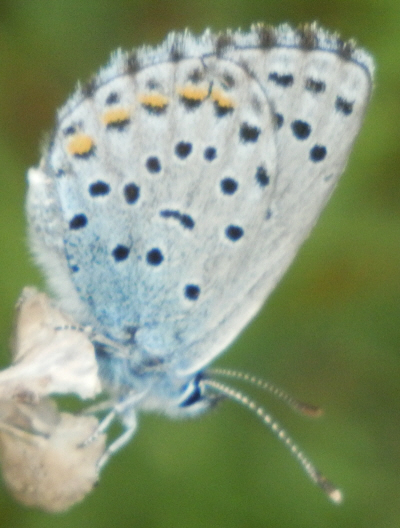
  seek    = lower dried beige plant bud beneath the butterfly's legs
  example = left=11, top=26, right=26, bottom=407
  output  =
left=0, top=400, right=106, bottom=512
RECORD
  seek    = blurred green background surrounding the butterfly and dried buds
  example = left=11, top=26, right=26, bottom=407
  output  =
left=0, top=0, right=400, bottom=528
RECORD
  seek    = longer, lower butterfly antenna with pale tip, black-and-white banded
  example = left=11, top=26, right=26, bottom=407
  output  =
left=201, top=378, right=343, bottom=504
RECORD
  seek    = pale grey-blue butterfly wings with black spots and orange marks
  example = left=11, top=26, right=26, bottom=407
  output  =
left=28, top=28, right=371, bottom=374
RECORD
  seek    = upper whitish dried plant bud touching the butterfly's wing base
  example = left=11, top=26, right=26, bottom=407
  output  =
left=0, top=288, right=101, bottom=401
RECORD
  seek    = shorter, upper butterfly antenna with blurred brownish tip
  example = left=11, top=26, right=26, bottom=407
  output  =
left=207, top=368, right=323, bottom=418
